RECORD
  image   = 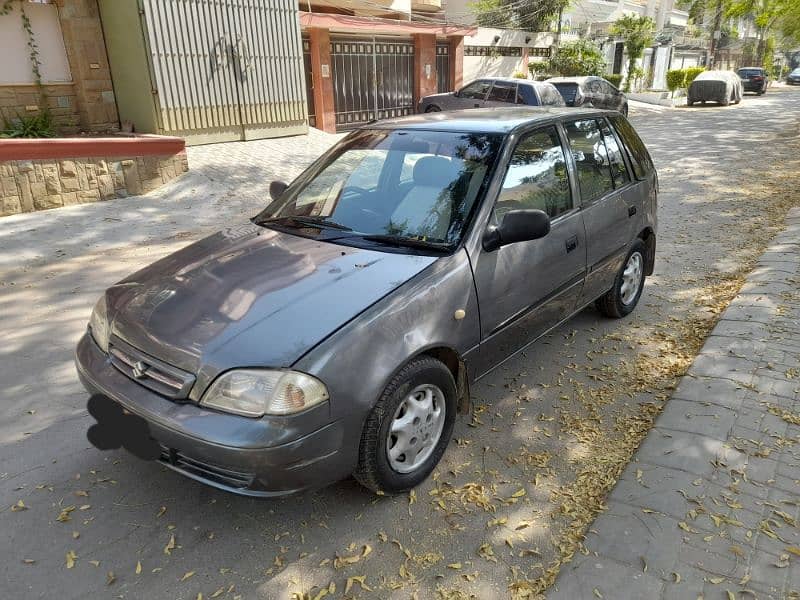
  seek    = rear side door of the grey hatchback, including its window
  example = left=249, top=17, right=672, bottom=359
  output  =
left=564, top=117, right=642, bottom=304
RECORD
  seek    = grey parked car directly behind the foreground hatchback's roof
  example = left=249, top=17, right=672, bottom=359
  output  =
left=419, top=77, right=564, bottom=112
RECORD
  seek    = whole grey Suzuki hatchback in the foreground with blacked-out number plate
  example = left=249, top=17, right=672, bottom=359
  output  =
left=76, top=108, right=658, bottom=497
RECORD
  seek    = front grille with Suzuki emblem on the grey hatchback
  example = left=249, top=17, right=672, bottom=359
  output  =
left=108, top=337, right=195, bottom=400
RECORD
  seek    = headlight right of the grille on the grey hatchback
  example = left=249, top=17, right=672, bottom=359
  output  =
left=200, top=369, right=328, bottom=417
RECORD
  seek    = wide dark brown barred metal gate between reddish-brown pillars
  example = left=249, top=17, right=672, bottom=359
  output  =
left=331, top=37, right=414, bottom=130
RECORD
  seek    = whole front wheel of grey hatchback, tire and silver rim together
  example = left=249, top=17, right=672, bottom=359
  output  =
left=353, top=356, right=457, bottom=494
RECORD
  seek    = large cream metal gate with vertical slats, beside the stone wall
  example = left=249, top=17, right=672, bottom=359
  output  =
left=142, top=0, right=308, bottom=143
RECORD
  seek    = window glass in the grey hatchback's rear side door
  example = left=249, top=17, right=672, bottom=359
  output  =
left=564, top=119, right=614, bottom=204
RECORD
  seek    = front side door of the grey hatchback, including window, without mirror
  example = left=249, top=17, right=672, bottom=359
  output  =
left=471, top=125, right=586, bottom=375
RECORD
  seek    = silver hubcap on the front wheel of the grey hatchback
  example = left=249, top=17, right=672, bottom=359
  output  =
left=386, top=384, right=445, bottom=473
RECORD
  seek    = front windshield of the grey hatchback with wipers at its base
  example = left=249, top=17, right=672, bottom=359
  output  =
left=254, top=129, right=503, bottom=248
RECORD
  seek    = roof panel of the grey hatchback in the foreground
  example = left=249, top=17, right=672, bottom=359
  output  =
left=361, top=106, right=614, bottom=134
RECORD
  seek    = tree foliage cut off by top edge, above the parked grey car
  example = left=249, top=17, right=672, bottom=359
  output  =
left=468, top=0, right=569, bottom=31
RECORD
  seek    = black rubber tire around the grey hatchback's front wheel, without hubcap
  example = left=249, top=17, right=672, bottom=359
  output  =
left=353, top=356, right=457, bottom=494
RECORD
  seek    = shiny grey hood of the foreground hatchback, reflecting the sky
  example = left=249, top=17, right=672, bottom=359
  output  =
left=107, top=224, right=436, bottom=373
